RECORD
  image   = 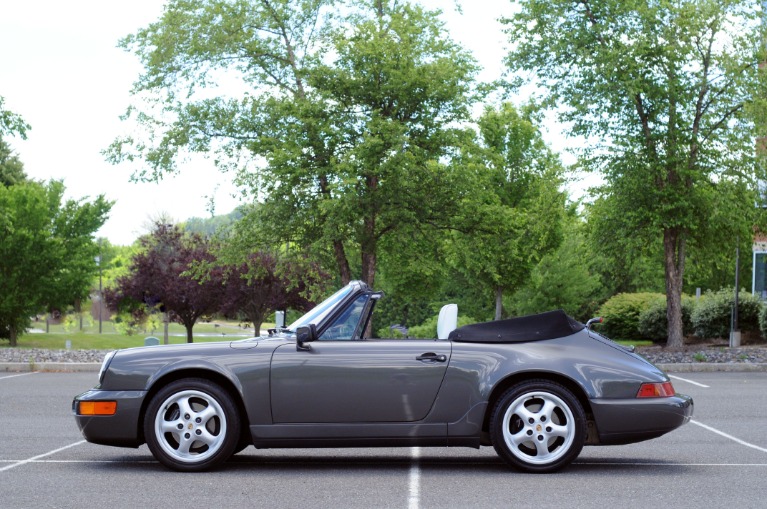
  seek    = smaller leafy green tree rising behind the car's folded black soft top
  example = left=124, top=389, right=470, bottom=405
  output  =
left=450, top=103, right=565, bottom=320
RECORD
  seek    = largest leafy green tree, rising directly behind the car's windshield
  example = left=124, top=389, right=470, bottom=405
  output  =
left=108, top=0, right=476, bottom=285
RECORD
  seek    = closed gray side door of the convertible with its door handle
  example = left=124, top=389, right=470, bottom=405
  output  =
left=270, top=337, right=451, bottom=424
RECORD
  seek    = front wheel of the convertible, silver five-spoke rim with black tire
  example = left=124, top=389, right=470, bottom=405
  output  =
left=144, top=378, right=241, bottom=472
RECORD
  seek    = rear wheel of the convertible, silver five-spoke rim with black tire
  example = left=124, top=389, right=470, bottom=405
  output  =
left=490, top=380, right=586, bottom=473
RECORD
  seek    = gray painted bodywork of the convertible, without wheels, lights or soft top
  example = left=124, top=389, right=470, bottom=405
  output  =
left=73, top=283, right=692, bottom=447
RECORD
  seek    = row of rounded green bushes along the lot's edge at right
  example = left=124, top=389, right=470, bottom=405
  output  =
left=599, top=289, right=767, bottom=342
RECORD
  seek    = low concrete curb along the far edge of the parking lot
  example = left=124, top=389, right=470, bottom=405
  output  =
left=0, top=362, right=767, bottom=373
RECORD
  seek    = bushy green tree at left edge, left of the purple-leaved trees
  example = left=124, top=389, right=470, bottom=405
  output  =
left=0, top=181, right=111, bottom=346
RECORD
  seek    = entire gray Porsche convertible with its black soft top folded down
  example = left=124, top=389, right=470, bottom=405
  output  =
left=72, top=281, right=693, bottom=472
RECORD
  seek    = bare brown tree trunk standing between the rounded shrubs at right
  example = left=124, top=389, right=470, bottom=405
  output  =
left=663, top=228, right=685, bottom=348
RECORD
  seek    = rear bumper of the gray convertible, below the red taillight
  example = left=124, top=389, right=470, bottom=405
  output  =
left=590, top=394, right=694, bottom=445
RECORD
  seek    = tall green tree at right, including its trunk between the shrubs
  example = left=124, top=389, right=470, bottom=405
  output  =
left=506, top=0, right=764, bottom=346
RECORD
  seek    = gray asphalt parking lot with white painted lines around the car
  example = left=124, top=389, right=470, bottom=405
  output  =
left=0, top=372, right=767, bottom=509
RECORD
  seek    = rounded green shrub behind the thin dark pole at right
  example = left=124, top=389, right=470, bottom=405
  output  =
left=692, top=288, right=762, bottom=339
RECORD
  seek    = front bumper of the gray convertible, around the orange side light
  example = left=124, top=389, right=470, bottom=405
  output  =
left=72, top=389, right=146, bottom=447
